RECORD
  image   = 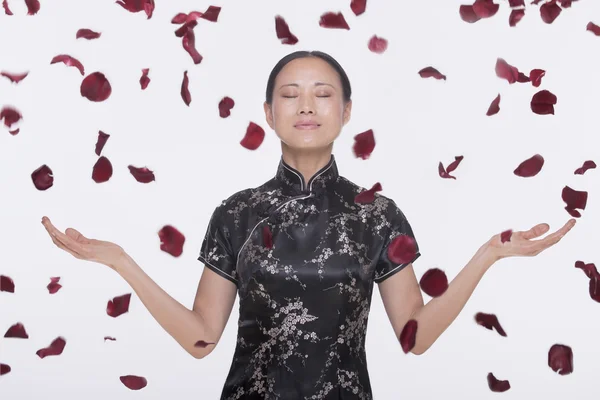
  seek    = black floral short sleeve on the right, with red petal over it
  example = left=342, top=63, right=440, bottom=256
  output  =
left=373, top=200, right=421, bottom=283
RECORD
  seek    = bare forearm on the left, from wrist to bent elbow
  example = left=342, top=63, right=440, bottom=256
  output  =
left=115, top=254, right=214, bottom=358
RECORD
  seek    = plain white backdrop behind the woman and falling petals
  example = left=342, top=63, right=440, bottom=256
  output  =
left=0, top=0, right=600, bottom=400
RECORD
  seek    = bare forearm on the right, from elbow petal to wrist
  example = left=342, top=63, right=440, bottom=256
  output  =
left=412, top=246, right=494, bottom=354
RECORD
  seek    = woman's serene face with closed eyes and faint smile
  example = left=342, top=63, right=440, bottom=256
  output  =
left=264, top=57, right=352, bottom=150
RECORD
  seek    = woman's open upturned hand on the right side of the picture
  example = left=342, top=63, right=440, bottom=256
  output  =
left=486, top=218, right=576, bottom=261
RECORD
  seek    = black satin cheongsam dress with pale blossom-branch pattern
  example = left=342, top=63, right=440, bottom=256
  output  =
left=198, top=155, right=420, bottom=400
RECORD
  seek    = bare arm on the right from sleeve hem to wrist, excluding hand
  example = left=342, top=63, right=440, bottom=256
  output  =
left=379, top=242, right=494, bottom=354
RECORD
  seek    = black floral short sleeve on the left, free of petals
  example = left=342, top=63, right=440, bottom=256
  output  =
left=198, top=205, right=238, bottom=286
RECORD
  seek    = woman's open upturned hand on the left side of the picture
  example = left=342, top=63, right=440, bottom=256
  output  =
left=42, top=216, right=125, bottom=271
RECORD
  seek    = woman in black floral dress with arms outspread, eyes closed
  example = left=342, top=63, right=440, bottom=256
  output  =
left=42, top=51, right=575, bottom=399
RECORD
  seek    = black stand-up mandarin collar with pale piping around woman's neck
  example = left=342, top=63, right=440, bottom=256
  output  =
left=275, top=154, right=339, bottom=194
